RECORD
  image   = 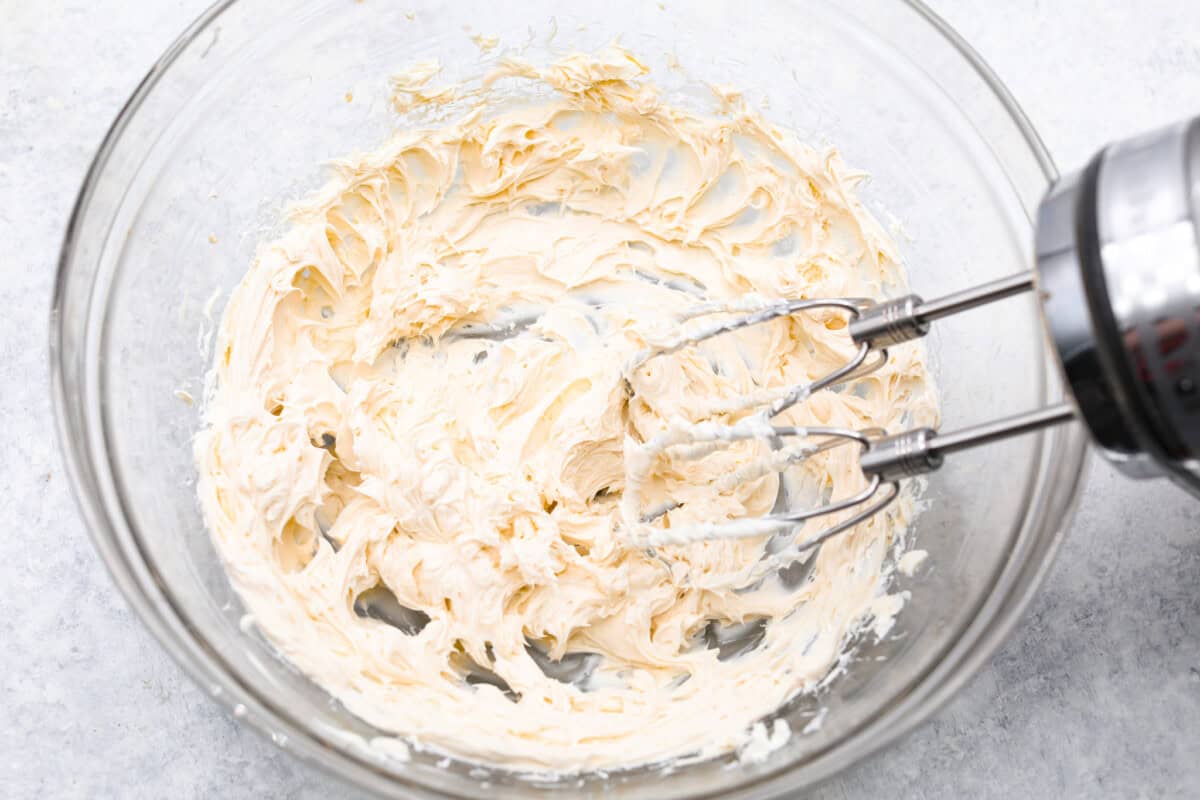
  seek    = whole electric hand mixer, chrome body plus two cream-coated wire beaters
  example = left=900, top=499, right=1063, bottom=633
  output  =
left=640, top=116, right=1200, bottom=552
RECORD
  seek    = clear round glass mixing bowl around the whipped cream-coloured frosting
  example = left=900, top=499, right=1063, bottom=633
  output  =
left=52, top=0, right=1085, bottom=798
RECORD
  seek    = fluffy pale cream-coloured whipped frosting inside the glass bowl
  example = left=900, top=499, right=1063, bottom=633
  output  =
left=197, top=47, right=935, bottom=770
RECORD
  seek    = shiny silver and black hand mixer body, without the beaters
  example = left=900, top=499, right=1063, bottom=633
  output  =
left=1037, top=112, right=1200, bottom=494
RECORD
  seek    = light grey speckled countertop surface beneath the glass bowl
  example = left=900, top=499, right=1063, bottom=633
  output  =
left=0, top=0, right=1200, bottom=800
